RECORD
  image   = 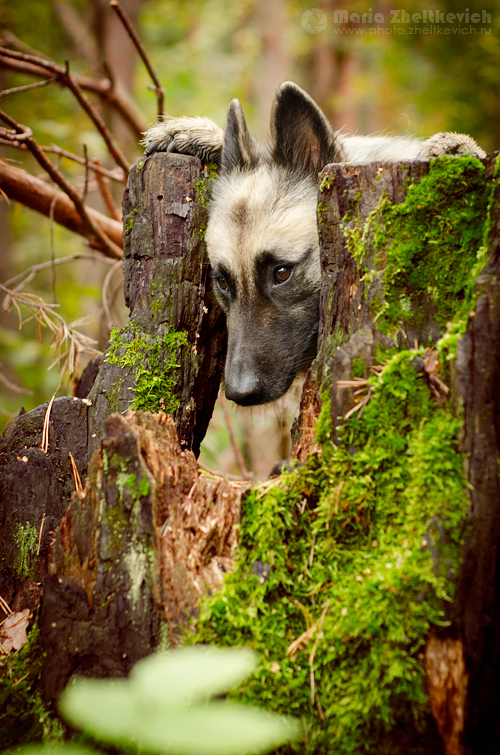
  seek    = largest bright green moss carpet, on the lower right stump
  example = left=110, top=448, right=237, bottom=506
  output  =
left=194, top=351, right=468, bottom=755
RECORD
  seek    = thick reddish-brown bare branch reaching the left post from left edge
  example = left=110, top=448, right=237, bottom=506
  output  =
left=0, top=160, right=122, bottom=259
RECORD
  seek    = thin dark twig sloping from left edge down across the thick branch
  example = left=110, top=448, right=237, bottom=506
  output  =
left=0, top=110, right=122, bottom=259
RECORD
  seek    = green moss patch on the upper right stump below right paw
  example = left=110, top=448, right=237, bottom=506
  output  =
left=345, top=156, right=491, bottom=335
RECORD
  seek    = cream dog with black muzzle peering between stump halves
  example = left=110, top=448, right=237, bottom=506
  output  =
left=143, top=82, right=485, bottom=406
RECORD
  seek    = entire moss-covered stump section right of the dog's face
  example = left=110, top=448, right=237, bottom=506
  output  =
left=194, top=157, right=500, bottom=755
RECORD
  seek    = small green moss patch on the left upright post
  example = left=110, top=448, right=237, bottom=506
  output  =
left=107, top=323, right=189, bottom=414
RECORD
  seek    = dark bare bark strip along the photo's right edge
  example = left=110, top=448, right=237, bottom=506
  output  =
left=455, top=184, right=500, bottom=755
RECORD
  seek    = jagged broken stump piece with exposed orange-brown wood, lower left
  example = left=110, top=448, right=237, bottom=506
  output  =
left=42, top=412, right=242, bottom=700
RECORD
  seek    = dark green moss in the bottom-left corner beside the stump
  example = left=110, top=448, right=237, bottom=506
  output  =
left=0, top=625, right=61, bottom=750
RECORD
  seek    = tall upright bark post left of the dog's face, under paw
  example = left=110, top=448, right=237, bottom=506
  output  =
left=89, top=154, right=225, bottom=458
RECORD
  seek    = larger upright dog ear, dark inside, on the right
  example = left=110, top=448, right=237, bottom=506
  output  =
left=271, top=81, right=345, bottom=175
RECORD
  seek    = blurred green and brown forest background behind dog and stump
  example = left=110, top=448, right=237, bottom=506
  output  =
left=0, top=0, right=500, bottom=479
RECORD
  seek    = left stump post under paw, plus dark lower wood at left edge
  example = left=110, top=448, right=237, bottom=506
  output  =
left=0, top=154, right=225, bottom=606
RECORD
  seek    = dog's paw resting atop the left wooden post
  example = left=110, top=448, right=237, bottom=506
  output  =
left=142, top=117, right=223, bottom=161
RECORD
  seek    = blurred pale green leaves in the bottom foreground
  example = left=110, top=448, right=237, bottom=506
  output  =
left=10, top=647, right=301, bottom=755
